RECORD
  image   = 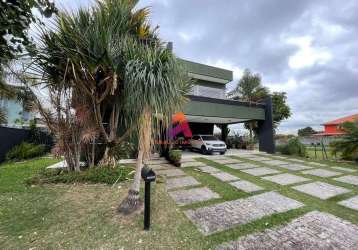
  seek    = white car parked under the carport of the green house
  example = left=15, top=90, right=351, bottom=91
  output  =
left=190, top=135, right=226, bottom=155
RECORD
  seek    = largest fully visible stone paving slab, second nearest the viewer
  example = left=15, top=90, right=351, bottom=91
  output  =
left=185, top=192, right=304, bottom=235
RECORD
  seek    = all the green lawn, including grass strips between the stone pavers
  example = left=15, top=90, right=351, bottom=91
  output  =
left=0, top=157, right=358, bottom=249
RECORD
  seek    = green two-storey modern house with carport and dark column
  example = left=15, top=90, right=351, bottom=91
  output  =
left=178, top=60, right=275, bottom=153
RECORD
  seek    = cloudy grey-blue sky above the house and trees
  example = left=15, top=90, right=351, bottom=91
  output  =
left=56, top=0, right=358, bottom=133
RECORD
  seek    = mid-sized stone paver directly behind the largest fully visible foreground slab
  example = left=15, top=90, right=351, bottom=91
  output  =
left=169, top=187, right=220, bottom=206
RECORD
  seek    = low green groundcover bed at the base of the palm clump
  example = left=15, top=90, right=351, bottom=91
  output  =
left=26, top=166, right=134, bottom=185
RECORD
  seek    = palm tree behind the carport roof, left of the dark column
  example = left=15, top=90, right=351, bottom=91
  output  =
left=227, top=69, right=269, bottom=143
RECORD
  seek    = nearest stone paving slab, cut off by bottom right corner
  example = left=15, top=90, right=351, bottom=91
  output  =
left=216, top=211, right=358, bottom=250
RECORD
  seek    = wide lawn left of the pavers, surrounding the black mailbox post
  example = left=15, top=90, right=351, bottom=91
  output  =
left=0, top=159, right=207, bottom=249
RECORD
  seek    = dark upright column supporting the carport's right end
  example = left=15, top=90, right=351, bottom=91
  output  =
left=258, top=97, right=276, bottom=154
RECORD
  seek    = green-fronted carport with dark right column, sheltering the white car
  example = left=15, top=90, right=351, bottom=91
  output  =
left=184, top=96, right=275, bottom=153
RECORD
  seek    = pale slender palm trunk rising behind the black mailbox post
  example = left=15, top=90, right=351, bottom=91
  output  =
left=118, top=108, right=152, bottom=214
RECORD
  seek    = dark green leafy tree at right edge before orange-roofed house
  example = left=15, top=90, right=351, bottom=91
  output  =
left=331, top=121, right=358, bottom=161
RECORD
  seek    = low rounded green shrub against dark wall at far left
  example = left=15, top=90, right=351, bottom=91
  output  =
left=6, top=142, right=47, bottom=161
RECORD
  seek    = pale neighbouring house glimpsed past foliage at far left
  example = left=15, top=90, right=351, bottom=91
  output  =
left=0, top=95, right=33, bottom=127
